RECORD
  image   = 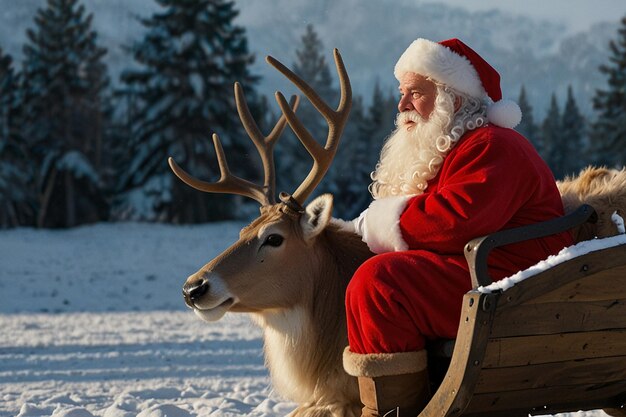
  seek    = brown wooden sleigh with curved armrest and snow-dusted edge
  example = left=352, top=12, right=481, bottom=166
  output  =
left=420, top=206, right=626, bottom=417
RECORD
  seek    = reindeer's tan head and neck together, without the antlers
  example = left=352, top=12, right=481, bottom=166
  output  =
left=187, top=195, right=372, bottom=417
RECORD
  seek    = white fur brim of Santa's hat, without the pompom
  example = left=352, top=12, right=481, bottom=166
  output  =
left=393, top=38, right=487, bottom=99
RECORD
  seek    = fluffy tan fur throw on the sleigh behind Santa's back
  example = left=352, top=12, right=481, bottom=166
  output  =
left=557, top=167, right=626, bottom=242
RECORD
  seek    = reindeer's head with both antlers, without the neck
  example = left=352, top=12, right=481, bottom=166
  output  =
left=169, top=49, right=351, bottom=321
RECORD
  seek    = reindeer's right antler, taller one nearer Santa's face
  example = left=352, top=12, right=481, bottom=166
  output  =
left=266, top=48, right=352, bottom=205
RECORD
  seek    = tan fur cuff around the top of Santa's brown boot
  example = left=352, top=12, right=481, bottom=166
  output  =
left=343, top=346, right=428, bottom=378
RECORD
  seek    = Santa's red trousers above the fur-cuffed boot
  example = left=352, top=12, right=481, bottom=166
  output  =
left=346, top=250, right=472, bottom=353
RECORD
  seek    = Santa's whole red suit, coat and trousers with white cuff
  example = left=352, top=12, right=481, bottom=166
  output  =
left=347, top=125, right=573, bottom=353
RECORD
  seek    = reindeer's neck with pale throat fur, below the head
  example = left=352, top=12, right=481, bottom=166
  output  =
left=249, top=224, right=372, bottom=403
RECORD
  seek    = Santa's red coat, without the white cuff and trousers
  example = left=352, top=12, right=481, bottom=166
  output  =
left=400, top=126, right=573, bottom=278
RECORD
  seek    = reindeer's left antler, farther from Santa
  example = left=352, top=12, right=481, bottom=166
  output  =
left=168, top=82, right=299, bottom=206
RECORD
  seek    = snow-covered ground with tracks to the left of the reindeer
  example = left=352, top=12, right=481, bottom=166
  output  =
left=0, top=223, right=616, bottom=417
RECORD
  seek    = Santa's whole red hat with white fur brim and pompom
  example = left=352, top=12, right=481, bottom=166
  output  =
left=394, top=39, right=522, bottom=128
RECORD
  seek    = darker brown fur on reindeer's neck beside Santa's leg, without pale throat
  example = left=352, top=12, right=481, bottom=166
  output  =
left=288, top=224, right=372, bottom=417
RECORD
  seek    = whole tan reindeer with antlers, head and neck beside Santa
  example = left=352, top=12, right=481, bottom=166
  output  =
left=169, top=49, right=372, bottom=416
